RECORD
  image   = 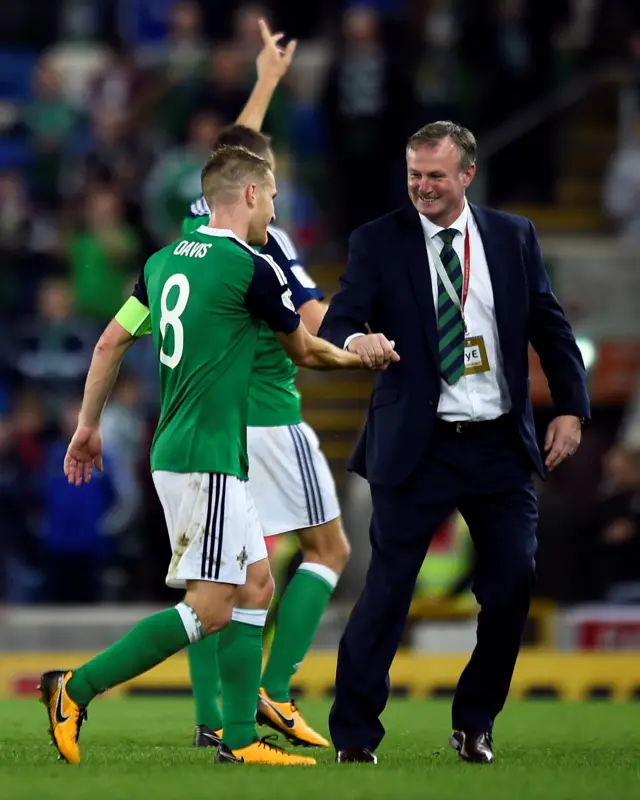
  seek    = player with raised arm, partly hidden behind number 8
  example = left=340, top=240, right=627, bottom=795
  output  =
left=183, top=22, right=356, bottom=747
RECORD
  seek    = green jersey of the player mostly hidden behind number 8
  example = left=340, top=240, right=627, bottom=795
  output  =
left=182, top=212, right=323, bottom=427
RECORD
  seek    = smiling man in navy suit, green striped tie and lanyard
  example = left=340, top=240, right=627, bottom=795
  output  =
left=320, top=122, right=590, bottom=763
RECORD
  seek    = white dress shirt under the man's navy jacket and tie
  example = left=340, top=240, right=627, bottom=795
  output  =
left=420, top=200, right=511, bottom=422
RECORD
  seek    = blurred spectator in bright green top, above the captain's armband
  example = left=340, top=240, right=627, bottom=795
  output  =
left=67, top=185, right=141, bottom=324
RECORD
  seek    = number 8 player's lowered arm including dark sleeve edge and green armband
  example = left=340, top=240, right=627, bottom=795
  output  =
left=64, top=271, right=149, bottom=486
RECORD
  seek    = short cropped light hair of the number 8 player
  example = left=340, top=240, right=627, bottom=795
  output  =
left=201, top=146, right=271, bottom=208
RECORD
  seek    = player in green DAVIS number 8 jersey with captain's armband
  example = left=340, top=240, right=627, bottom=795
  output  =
left=40, top=141, right=398, bottom=765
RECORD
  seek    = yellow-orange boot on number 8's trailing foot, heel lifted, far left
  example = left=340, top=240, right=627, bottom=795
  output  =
left=38, top=670, right=87, bottom=764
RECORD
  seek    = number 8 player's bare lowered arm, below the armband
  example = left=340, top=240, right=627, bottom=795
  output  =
left=64, top=320, right=137, bottom=486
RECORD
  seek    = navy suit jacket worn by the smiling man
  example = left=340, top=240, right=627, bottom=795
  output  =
left=319, top=206, right=590, bottom=485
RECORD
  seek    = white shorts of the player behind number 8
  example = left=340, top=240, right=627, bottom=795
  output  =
left=247, top=422, right=340, bottom=536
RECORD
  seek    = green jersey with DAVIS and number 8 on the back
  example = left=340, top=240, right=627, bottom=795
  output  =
left=116, top=225, right=300, bottom=480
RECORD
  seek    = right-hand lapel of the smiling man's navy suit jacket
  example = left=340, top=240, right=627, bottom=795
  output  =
left=471, top=206, right=513, bottom=354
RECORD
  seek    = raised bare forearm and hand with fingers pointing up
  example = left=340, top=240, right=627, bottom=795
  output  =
left=236, top=19, right=297, bottom=131
